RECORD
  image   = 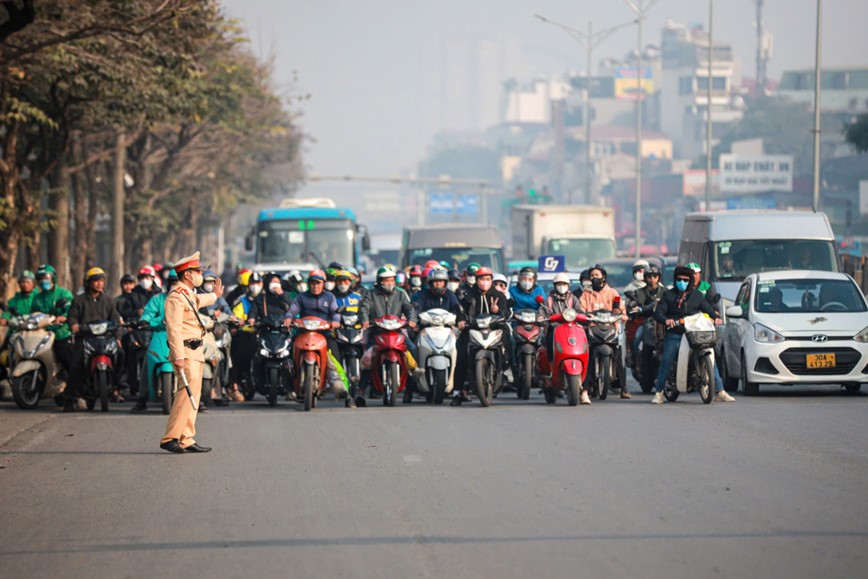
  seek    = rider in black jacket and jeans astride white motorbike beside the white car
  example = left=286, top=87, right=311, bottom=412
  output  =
left=651, top=265, right=735, bottom=404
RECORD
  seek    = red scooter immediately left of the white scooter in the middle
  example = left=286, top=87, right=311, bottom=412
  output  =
left=371, top=316, right=409, bottom=406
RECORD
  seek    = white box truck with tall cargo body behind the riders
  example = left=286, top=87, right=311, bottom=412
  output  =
left=512, top=205, right=615, bottom=271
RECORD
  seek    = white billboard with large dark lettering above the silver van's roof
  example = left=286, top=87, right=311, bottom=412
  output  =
left=720, top=155, right=793, bottom=193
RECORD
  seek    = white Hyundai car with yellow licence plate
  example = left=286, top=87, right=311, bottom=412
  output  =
left=723, top=270, right=868, bottom=396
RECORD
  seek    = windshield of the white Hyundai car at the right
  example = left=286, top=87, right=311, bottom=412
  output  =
left=754, top=279, right=866, bottom=314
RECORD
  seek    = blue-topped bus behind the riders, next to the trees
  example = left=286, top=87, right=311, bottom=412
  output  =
left=245, top=197, right=370, bottom=274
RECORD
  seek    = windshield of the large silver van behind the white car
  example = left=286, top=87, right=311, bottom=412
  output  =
left=709, top=239, right=838, bottom=281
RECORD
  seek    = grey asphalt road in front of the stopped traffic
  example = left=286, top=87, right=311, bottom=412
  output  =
left=0, top=380, right=868, bottom=578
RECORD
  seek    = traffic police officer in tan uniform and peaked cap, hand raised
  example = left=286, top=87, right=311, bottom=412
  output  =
left=160, top=251, right=223, bottom=453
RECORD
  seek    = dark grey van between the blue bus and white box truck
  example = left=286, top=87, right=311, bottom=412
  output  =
left=400, top=224, right=506, bottom=272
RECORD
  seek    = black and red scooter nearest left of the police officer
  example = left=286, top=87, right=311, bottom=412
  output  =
left=79, top=320, right=119, bottom=412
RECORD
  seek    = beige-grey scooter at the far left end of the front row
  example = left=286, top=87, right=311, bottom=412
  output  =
left=9, top=313, right=66, bottom=410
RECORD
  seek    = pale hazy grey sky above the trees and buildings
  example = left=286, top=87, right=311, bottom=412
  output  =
left=222, top=0, right=868, bottom=176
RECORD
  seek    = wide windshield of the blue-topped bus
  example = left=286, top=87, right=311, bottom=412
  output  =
left=257, top=219, right=355, bottom=266
